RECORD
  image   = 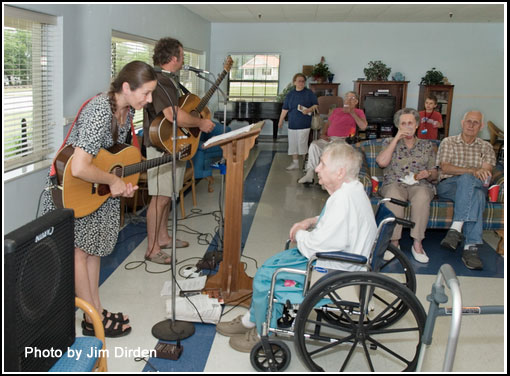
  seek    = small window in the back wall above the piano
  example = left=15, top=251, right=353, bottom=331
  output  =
left=228, top=54, right=280, bottom=102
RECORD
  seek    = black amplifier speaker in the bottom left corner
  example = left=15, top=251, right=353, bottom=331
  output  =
left=4, top=209, right=76, bottom=372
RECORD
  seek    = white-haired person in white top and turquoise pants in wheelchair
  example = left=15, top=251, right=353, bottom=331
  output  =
left=216, top=143, right=377, bottom=352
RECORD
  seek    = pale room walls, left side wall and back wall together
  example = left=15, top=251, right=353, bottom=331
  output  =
left=3, top=7, right=506, bottom=232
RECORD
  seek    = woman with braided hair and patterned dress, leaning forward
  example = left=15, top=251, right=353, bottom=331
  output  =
left=43, top=61, right=157, bottom=337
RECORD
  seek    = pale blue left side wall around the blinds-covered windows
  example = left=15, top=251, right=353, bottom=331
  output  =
left=3, top=4, right=211, bottom=233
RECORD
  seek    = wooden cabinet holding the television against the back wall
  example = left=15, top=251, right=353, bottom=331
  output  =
left=354, top=81, right=409, bottom=139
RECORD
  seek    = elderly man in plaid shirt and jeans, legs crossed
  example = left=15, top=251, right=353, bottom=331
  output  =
left=437, top=111, right=496, bottom=270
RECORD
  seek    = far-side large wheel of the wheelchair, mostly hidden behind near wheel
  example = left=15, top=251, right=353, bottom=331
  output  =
left=322, top=244, right=416, bottom=329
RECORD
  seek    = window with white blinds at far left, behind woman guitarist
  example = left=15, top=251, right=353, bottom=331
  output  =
left=3, top=6, right=57, bottom=171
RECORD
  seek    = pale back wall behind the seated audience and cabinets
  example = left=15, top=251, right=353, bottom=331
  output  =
left=211, top=23, right=506, bottom=138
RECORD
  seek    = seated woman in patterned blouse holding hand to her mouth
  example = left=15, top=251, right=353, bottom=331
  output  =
left=376, top=108, right=438, bottom=263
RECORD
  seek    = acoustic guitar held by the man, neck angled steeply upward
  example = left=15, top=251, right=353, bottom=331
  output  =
left=149, top=56, right=233, bottom=160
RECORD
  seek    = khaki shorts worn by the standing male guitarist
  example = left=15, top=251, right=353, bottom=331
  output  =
left=147, top=146, right=186, bottom=197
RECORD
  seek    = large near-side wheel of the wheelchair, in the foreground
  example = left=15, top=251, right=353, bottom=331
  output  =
left=294, top=272, right=426, bottom=372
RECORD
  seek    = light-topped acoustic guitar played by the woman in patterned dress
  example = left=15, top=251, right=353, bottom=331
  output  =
left=51, top=144, right=191, bottom=218
